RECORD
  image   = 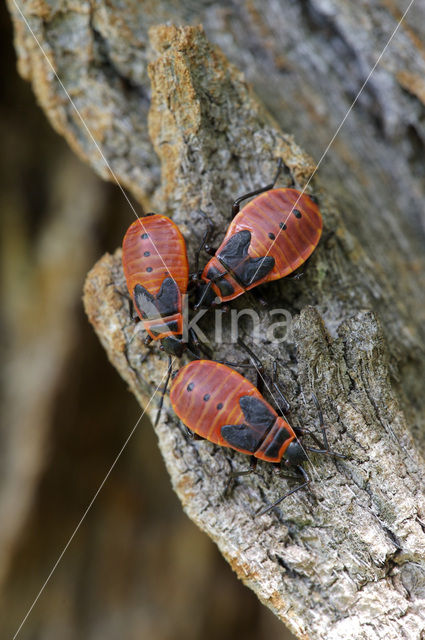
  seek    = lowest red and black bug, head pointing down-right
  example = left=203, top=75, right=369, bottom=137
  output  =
left=170, top=352, right=339, bottom=515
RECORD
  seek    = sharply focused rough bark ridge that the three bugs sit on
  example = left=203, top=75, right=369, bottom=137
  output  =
left=86, top=22, right=425, bottom=638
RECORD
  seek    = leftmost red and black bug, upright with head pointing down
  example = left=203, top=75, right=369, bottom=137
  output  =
left=122, top=214, right=189, bottom=356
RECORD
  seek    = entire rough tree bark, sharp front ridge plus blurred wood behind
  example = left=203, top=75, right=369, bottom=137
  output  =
left=5, top=1, right=425, bottom=640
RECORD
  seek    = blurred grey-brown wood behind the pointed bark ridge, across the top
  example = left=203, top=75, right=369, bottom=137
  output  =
left=8, top=0, right=425, bottom=436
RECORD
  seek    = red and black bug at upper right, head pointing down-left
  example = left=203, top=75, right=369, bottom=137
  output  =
left=195, top=160, right=322, bottom=307
